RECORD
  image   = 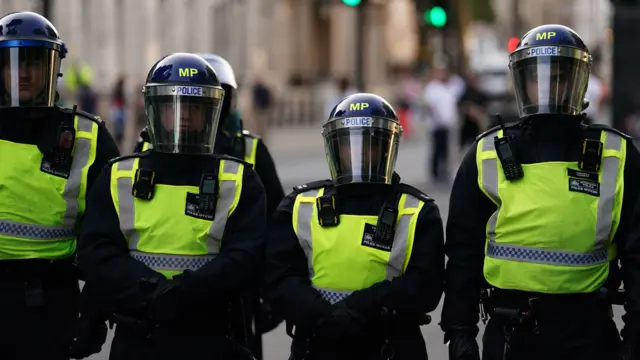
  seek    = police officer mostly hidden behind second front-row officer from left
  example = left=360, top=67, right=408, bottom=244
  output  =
left=135, top=54, right=284, bottom=359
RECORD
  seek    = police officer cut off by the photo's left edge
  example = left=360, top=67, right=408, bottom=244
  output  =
left=0, top=12, right=119, bottom=360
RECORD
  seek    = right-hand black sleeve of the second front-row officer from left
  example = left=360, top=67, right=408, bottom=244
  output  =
left=183, top=167, right=267, bottom=300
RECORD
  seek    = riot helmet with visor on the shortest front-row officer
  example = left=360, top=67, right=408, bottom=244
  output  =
left=322, top=93, right=402, bottom=185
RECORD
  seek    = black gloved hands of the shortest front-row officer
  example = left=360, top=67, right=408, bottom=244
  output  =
left=315, top=301, right=368, bottom=339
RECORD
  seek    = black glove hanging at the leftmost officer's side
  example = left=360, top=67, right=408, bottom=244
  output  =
left=69, top=316, right=107, bottom=359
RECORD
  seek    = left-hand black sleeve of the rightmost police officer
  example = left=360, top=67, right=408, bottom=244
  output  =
left=441, top=143, right=497, bottom=336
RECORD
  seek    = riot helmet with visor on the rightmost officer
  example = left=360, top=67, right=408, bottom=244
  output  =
left=509, top=25, right=592, bottom=117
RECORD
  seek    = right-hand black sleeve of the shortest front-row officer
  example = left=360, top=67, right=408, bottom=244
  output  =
left=345, top=202, right=444, bottom=316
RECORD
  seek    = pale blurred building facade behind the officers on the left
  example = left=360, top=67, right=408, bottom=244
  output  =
left=0, top=0, right=413, bottom=94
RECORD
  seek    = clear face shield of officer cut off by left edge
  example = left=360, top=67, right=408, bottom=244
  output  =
left=0, top=47, right=60, bottom=107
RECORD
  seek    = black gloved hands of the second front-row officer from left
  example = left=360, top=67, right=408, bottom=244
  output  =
left=140, top=276, right=186, bottom=324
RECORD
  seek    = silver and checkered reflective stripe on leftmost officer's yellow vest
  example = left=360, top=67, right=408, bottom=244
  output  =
left=0, top=116, right=94, bottom=241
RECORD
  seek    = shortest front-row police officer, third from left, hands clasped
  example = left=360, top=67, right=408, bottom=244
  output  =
left=265, top=93, right=444, bottom=359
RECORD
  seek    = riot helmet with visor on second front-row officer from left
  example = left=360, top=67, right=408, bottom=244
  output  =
left=143, top=53, right=224, bottom=154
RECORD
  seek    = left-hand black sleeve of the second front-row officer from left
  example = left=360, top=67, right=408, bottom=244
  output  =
left=78, top=168, right=162, bottom=307
